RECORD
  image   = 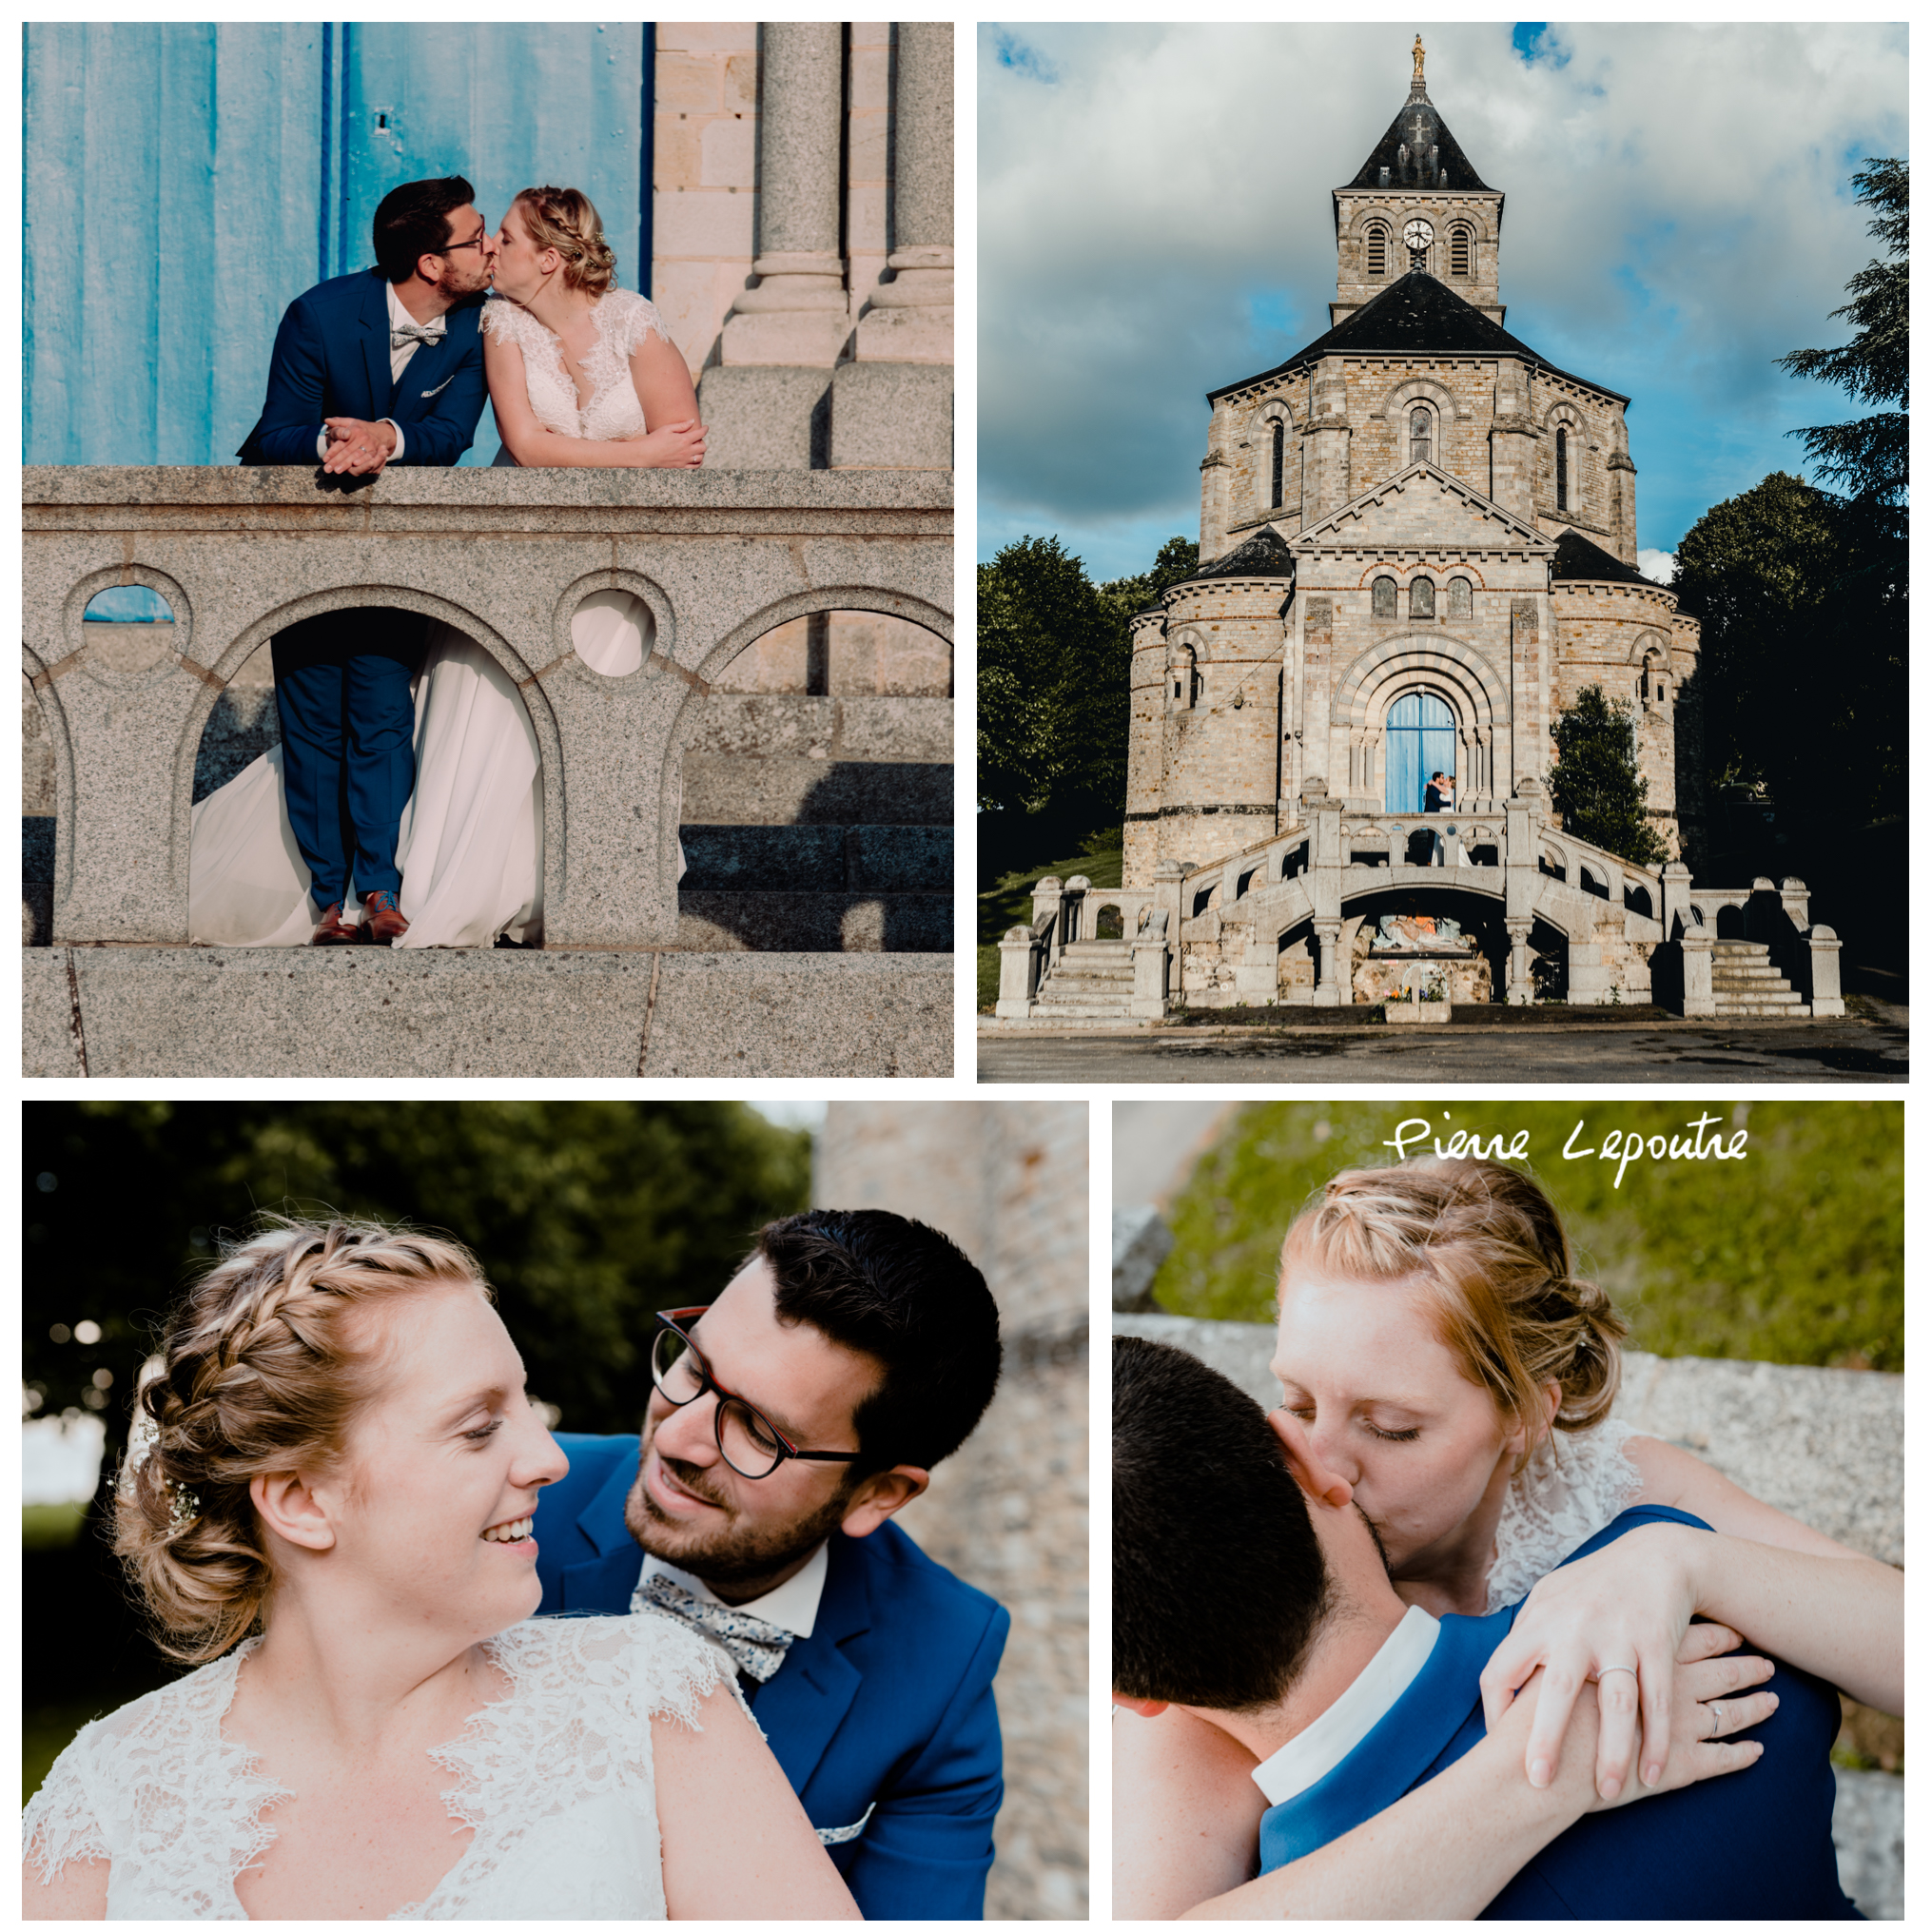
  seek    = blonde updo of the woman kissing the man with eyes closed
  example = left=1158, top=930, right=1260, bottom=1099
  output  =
left=1281, top=1160, right=1629, bottom=1445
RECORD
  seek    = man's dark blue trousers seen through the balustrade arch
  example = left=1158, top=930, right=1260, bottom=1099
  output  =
left=274, top=611, right=425, bottom=907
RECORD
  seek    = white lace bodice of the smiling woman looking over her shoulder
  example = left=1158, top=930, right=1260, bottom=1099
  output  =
left=21, top=1615, right=742, bottom=1919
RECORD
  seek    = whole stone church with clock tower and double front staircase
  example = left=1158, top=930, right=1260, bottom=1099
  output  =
left=995, top=37, right=1844, bottom=1022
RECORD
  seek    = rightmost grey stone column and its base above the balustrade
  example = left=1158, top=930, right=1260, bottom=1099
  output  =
left=830, top=19, right=952, bottom=470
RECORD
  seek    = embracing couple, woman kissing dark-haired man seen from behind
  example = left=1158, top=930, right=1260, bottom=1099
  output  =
left=1113, top=1160, right=1905, bottom=1921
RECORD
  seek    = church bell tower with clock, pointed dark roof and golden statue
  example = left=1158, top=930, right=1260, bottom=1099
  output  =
left=1329, top=33, right=1503, bottom=328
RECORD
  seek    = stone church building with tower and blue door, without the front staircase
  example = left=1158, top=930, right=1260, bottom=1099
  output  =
left=1124, top=39, right=1700, bottom=885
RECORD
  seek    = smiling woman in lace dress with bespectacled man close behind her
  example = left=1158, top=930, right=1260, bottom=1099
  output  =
left=21, top=1209, right=1008, bottom=1921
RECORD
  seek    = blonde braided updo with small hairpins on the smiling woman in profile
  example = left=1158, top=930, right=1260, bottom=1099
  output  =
left=114, top=1215, right=491, bottom=1664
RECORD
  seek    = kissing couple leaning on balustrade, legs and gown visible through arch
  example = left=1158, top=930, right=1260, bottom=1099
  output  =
left=189, top=176, right=705, bottom=946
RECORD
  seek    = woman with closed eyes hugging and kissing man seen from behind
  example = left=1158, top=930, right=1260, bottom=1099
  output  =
left=1113, top=1160, right=1905, bottom=1919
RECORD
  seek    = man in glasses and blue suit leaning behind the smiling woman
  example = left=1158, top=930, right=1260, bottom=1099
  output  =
left=537, top=1209, right=1008, bottom=1919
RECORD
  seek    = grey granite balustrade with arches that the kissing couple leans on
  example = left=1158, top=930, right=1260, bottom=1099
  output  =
left=21, top=468, right=952, bottom=948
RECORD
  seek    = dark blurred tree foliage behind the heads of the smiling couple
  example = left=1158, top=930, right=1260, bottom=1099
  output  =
left=21, top=1100, right=810, bottom=1443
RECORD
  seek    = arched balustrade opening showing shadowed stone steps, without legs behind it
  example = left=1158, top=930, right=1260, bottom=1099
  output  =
left=676, top=597, right=954, bottom=952
